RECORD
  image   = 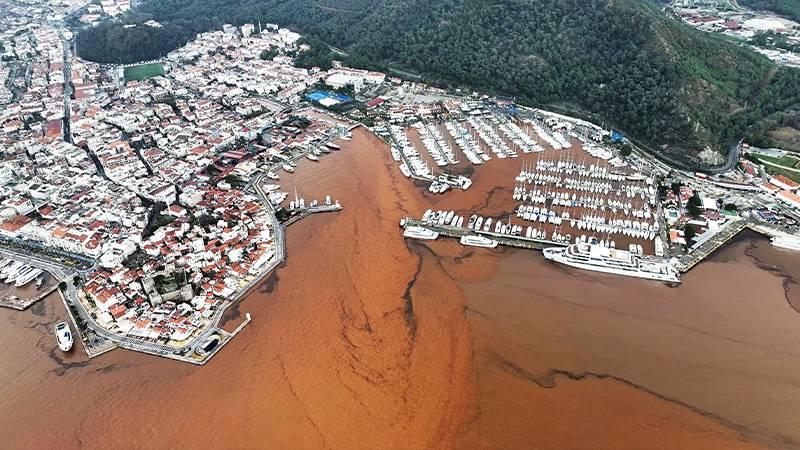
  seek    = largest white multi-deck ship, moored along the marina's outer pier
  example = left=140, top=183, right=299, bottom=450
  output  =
left=544, top=243, right=681, bottom=283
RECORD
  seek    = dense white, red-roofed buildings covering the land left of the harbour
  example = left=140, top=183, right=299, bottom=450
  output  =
left=0, top=20, right=354, bottom=342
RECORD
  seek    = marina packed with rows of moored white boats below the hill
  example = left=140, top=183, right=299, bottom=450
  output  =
left=382, top=103, right=800, bottom=283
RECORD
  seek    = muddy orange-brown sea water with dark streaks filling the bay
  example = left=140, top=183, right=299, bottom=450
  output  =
left=0, top=130, right=800, bottom=449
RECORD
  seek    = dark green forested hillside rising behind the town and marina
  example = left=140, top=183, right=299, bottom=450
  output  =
left=73, top=0, right=800, bottom=166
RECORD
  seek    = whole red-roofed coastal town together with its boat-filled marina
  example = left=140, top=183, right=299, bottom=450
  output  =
left=0, top=0, right=800, bottom=364
